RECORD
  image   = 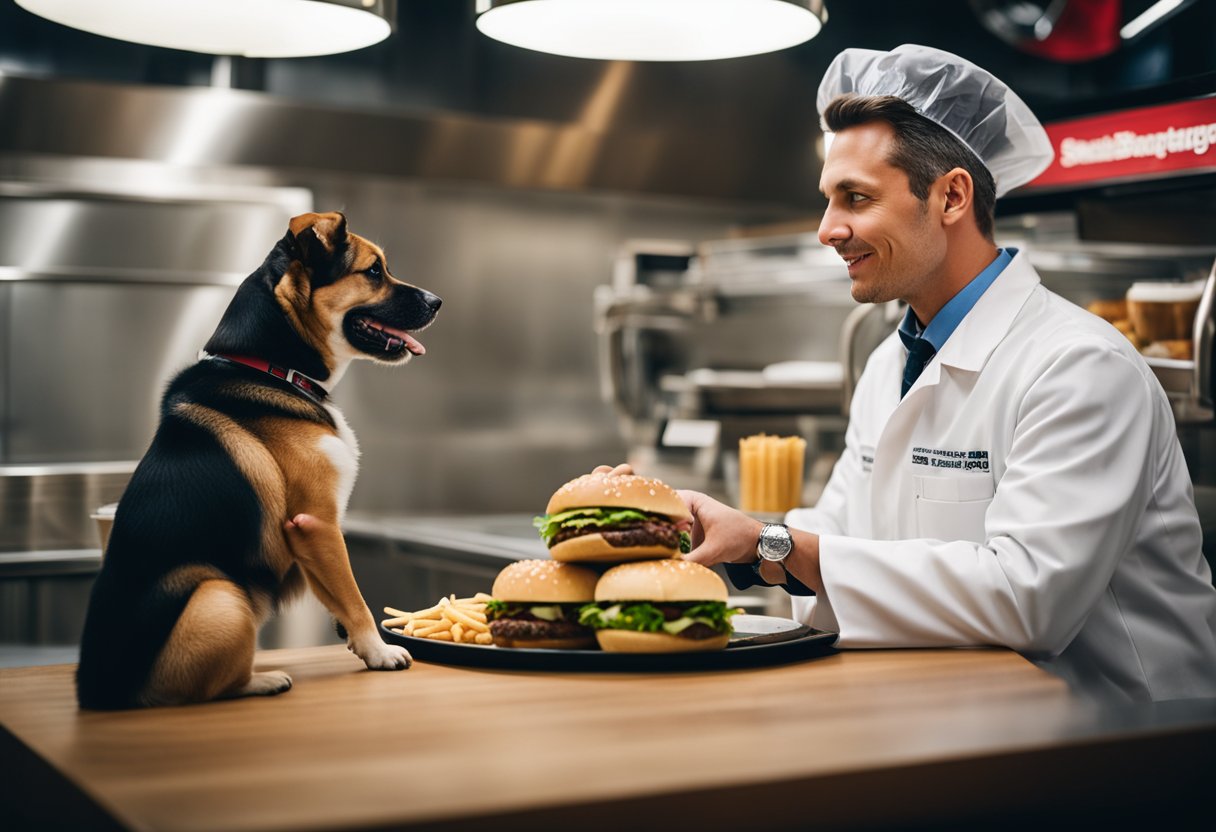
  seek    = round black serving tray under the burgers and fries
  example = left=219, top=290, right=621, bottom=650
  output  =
left=381, top=615, right=837, bottom=673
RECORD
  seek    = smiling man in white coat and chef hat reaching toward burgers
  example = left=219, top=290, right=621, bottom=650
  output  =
left=600, top=46, right=1216, bottom=701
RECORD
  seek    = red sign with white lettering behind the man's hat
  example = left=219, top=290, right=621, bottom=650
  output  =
left=1024, top=96, right=1216, bottom=189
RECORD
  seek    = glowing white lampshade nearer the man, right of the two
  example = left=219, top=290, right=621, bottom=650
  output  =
left=477, top=0, right=827, bottom=61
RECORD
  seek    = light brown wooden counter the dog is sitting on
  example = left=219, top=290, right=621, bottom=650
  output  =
left=0, top=646, right=1216, bottom=832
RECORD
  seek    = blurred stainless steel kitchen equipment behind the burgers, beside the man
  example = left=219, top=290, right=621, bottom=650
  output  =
left=596, top=234, right=870, bottom=501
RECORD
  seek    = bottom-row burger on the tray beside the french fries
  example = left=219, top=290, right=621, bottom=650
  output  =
left=485, top=561, right=598, bottom=650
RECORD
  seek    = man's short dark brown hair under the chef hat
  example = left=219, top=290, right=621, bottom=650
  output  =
left=823, top=92, right=996, bottom=240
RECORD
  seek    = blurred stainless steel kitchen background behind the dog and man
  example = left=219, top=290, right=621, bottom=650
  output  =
left=0, top=0, right=1216, bottom=662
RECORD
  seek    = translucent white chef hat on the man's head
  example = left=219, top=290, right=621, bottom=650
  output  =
left=816, top=44, right=1054, bottom=197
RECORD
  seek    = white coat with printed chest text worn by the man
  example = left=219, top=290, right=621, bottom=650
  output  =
left=787, top=252, right=1216, bottom=701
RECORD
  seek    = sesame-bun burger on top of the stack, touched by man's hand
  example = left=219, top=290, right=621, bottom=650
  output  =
left=533, top=474, right=692, bottom=562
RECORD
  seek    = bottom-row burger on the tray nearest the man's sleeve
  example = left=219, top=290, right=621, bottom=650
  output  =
left=579, top=561, right=739, bottom=653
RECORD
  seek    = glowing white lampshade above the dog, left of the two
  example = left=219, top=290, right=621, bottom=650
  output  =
left=17, top=0, right=395, bottom=57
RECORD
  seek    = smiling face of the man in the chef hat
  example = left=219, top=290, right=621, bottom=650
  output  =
left=820, top=122, right=946, bottom=307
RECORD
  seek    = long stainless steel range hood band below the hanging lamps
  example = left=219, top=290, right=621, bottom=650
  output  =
left=0, top=73, right=821, bottom=207
